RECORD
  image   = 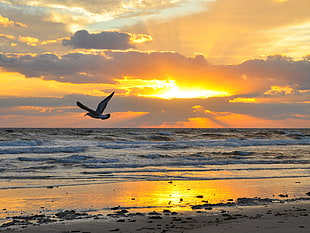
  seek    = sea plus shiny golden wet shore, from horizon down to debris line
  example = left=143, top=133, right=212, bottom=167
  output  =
left=0, top=128, right=310, bottom=223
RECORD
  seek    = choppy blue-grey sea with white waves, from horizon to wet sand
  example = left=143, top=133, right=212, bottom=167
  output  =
left=0, top=128, right=310, bottom=190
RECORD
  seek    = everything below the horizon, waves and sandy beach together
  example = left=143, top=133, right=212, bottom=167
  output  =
left=0, top=129, right=310, bottom=233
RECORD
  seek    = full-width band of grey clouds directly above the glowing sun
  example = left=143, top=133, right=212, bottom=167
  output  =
left=0, top=51, right=310, bottom=95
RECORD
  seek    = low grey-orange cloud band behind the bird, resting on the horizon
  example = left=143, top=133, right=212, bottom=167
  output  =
left=0, top=93, right=310, bottom=127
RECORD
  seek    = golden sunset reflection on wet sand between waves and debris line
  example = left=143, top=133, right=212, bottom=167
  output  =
left=0, top=178, right=310, bottom=223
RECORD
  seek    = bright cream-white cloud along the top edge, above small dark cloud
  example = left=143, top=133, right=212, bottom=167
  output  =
left=0, top=0, right=179, bottom=37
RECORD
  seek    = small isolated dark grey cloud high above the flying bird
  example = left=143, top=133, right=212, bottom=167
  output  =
left=62, top=30, right=134, bottom=50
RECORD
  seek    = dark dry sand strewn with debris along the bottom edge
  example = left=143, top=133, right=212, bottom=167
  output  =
left=0, top=198, right=310, bottom=233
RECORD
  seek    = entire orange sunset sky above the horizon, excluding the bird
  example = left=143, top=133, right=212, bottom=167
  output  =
left=0, top=0, right=310, bottom=128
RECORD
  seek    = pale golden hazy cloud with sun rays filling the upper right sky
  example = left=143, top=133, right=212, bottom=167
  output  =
left=121, top=0, right=310, bottom=64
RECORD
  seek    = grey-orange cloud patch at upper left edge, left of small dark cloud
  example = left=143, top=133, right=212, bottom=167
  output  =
left=0, top=1, right=71, bottom=54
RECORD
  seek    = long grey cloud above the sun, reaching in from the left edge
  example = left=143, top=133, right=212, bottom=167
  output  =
left=0, top=51, right=207, bottom=83
